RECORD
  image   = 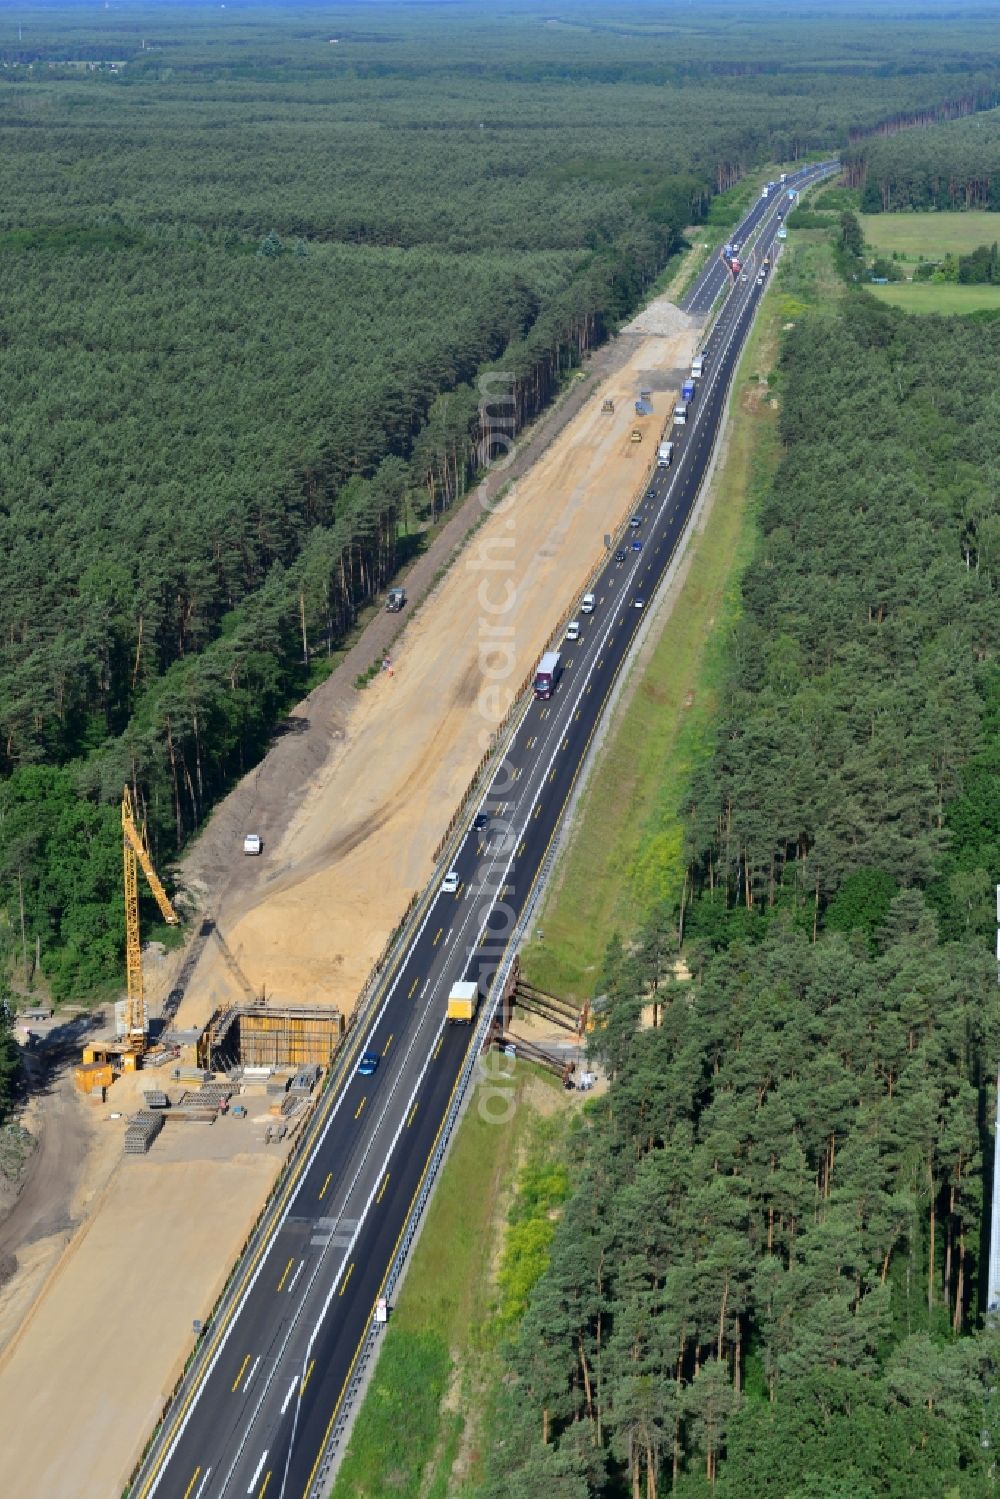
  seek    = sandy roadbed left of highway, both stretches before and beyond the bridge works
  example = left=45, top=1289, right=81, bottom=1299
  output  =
left=0, top=298, right=700, bottom=1499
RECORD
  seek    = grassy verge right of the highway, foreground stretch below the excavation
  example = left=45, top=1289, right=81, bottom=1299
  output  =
left=331, top=1063, right=561, bottom=1499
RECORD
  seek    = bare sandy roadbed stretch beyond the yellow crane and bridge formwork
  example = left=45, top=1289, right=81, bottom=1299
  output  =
left=170, top=309, right=697, bottom=1027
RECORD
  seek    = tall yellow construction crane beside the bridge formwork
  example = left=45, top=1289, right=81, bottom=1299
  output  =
left=76, top=785, right=180, bottom=1091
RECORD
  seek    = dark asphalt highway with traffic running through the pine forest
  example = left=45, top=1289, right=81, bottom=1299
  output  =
left=132, top=155, right=839, bottom=1499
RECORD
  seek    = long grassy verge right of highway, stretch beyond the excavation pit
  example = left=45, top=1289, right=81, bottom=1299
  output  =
left=522, top=231, right=841, bottom=1000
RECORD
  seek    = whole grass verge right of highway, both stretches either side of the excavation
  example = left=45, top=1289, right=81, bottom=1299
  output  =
left=333, top=208, right=840, bottom=1499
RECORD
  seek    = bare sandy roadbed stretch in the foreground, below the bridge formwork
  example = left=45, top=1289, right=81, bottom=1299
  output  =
left=0, top=1124, right=279, bottom=1499
